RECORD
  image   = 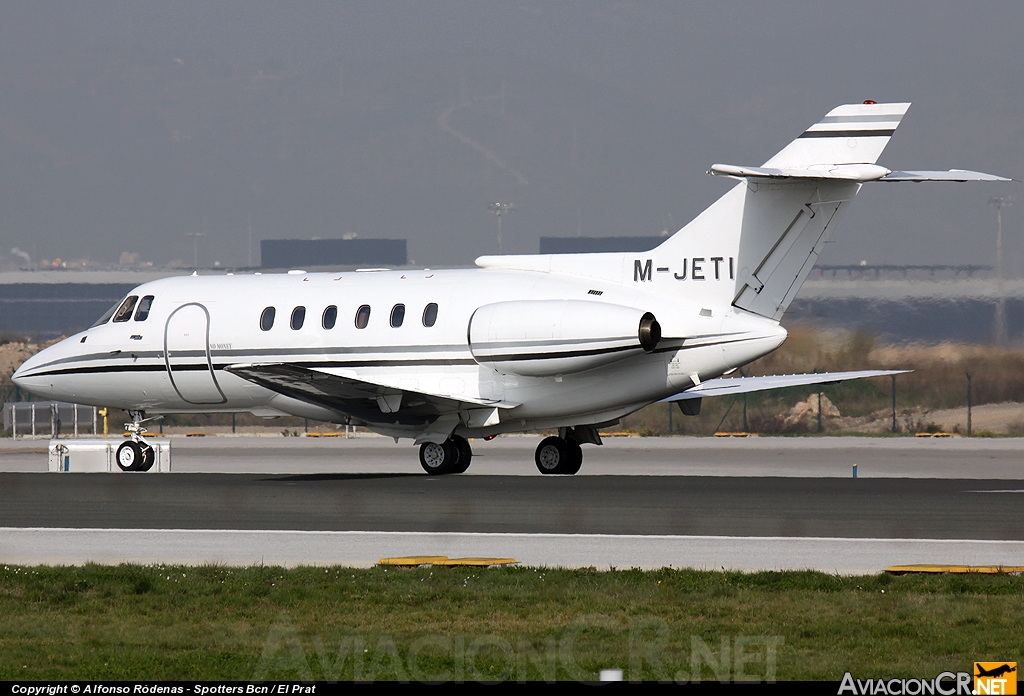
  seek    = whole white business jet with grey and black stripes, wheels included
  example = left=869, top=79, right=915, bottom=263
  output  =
left=13, top=101, right=1009, bottom=474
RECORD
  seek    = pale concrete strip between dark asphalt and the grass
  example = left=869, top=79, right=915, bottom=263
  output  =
left=0, top=527, right=1024, bottom=575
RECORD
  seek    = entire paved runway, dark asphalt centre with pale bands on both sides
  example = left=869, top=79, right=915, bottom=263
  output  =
left=0, top=438, right=1024, bottom=572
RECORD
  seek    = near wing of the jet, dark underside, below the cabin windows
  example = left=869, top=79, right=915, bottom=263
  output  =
left=224, top=363, right=519, bottom=427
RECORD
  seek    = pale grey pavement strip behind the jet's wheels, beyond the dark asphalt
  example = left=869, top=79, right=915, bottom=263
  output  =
left=0, top=435, right=1024, bottom=480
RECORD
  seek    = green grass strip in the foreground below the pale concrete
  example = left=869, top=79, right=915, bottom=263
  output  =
left=0, top=565, right=1024, bottom=682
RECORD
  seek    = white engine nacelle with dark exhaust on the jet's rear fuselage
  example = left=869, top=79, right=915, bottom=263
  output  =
left=469, top=300, right=662, bottom=377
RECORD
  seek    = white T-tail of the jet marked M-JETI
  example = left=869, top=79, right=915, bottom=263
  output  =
left=477, top=101, right=1010, bottom=321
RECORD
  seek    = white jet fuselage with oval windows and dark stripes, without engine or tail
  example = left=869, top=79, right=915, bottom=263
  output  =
left=16, top=269, right=785, bottom=435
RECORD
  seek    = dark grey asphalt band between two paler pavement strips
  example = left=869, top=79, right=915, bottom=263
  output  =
left=0, top=473, right=1024, bottom=540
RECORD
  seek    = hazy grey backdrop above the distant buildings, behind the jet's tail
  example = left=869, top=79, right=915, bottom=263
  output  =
left=0, top=0, right=1024, bottom=272
